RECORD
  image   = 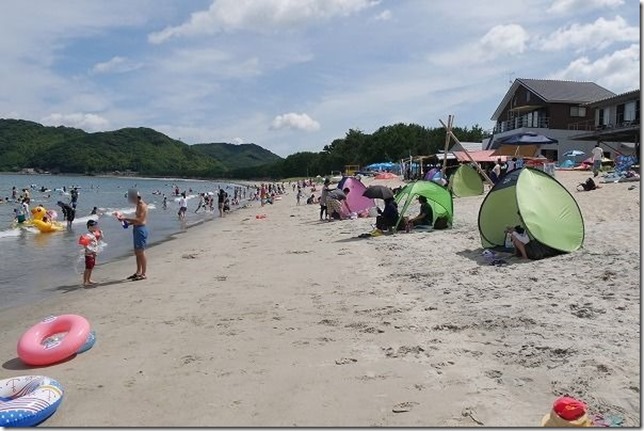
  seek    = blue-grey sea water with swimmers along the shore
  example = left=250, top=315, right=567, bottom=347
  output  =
left=0, top=174, right=245, bottom=310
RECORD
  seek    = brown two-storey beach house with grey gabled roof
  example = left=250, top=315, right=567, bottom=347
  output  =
left=485, top=78, right=615, bottom=162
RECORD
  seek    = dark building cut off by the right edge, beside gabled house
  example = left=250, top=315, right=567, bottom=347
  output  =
left=570, top=90, right=640, bottom=158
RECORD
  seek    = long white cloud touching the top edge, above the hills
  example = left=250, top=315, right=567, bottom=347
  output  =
left=148, top=0, right=379, bottom=43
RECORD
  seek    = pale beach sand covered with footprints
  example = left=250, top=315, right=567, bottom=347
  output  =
left=0, top=172, right=640, bottom=427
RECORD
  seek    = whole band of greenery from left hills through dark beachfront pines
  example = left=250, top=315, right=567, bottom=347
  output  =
left=0, top=119, right=486, bottom=179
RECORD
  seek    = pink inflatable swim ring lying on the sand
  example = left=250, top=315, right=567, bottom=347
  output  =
left=18, top=314, right=90, bottom=365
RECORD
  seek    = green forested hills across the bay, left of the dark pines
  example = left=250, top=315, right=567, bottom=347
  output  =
left=0, top=119, right=280, bottom=177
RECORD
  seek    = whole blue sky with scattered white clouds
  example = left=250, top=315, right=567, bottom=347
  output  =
left=0, top=0, right=640, bottom=157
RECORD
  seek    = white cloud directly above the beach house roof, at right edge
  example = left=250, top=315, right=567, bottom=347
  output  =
left=550, top=44, right=640, bottom=93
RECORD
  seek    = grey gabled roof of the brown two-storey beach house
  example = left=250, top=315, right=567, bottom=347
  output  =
left=492, top=78, right=615, bottom=121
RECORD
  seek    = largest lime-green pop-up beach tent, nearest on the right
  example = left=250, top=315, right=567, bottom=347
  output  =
left=479, top=168, right=584, bottom=257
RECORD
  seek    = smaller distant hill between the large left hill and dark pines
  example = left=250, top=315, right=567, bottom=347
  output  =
left=192, top=142, right=282, bottom=170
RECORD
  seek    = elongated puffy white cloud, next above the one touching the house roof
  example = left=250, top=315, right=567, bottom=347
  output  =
left=536, top=16, right=640, bottom=52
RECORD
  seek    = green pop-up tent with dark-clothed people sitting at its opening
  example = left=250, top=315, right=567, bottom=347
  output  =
left=395, top=180, right=454, bottom=230
